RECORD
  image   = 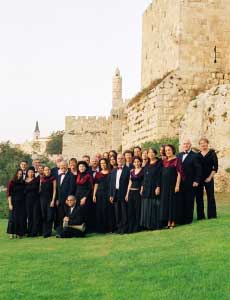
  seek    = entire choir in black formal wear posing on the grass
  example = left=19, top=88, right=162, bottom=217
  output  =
left=7, top=138, right=218, bottom=238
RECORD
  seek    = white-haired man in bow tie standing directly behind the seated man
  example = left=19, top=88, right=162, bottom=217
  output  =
left=56, top=161, right=76, bottom=237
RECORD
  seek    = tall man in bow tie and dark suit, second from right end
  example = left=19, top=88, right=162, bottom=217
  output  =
left=178, top=140, right=202, bottom=224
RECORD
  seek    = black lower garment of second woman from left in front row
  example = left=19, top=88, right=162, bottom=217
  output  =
left=26, top=197, right=41, bottom=236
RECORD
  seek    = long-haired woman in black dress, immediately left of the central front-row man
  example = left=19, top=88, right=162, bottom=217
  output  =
left=93, top=158, right=112, bottom=233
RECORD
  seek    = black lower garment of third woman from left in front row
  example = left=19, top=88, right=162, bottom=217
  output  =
left=40, top=198, right=54, bottom=235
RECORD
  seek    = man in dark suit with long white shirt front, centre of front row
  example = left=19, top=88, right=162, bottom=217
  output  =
left=110, top=154, right=130, bottom=234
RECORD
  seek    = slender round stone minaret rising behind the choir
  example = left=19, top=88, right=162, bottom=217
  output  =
left=111, top=68, right=123, bottom=150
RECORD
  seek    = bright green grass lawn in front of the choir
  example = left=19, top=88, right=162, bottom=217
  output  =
left=0, top=195, right=230, bottom=300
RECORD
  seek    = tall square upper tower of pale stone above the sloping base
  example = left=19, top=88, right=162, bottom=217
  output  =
left=142, top=0, right=230, bottom=88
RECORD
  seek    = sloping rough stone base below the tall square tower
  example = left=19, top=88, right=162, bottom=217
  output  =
left=122, top=70, right=230, bottom=149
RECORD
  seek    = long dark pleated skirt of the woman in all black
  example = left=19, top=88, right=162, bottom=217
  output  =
left=140, top=197, right=161, bottom=230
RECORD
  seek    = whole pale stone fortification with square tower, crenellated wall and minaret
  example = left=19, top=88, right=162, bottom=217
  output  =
left=63, top=0, right=230, bottom=190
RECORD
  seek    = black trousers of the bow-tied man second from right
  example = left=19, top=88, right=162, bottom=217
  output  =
left=180, top=182, right=197, bottom=224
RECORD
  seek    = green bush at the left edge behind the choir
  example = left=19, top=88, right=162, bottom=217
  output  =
left=0, top=142, right=32, bottom=186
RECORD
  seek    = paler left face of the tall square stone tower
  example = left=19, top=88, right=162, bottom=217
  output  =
left=141, top=0, right=180, bottom=88
